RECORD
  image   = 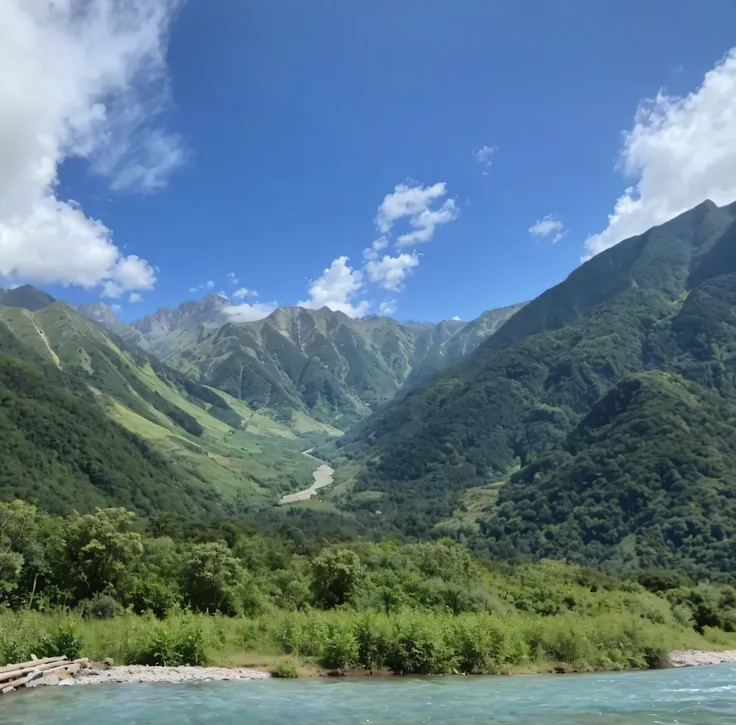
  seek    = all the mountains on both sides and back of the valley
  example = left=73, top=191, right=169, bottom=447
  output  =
left=0, top=195, right=736, bottom=580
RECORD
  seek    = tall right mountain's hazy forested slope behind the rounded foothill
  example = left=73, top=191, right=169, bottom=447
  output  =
left=336, top=202, right=736, bottom=576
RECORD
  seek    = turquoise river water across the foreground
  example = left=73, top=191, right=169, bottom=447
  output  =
left=0, top=665, right=736, bottom=725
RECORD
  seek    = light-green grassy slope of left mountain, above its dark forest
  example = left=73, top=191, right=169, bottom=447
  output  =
left=0, top=294, right=337, bottom=515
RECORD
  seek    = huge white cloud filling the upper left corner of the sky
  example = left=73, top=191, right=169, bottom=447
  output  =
left=0, top=0, right=183, bottom=297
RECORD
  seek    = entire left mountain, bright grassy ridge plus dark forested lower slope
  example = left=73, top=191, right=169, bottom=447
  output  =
left=0, top=295, right=335, bottom=516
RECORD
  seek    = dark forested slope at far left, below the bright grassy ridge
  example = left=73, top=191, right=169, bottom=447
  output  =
left=0, top=322, right=218, bottom=515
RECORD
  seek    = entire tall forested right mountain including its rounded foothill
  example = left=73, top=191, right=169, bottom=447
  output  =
left=333, top=201, right=736, bottom=576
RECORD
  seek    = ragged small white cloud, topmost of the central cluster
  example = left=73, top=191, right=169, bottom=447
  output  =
left=375, top=181, right=458, bottom=244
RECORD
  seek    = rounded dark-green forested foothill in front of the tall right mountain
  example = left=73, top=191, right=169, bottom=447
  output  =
left=481, top=372, right=736, bottom=577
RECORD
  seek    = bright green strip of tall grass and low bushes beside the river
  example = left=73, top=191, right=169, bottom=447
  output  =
left=0, top=611, right=736, bottom=676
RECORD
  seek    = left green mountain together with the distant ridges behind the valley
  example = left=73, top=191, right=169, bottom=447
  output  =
left=0, top=285, right=514, bottom=517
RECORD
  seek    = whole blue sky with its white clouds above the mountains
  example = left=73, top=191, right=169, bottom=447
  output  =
left=0, top=0, right=736, bottom=321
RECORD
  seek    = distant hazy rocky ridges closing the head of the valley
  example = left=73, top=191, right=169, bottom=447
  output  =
left=151, top=302, right=520, bottom=428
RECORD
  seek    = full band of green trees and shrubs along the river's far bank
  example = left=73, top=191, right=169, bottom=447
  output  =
left=0, top=501, right=736, bottom=674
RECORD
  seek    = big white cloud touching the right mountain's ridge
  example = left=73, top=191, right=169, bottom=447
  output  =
left=585, top=49, right=736, bottom=258
